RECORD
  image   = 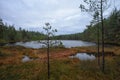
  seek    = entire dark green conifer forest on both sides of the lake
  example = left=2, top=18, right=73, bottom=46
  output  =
left=0, top=9, right=120, bottom=44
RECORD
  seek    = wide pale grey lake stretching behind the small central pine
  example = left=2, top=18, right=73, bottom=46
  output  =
left=7, top=40, right=96, bottom=49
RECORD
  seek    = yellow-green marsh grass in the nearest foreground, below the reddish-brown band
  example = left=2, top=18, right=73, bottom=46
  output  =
left=0, top=56, right=120, bottom=80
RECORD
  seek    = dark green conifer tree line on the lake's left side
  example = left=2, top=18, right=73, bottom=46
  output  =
left=0, top=19, right=45, bottom=43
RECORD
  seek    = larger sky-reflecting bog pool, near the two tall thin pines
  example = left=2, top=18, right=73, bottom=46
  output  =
left=70, top=53, right=96, bottom=60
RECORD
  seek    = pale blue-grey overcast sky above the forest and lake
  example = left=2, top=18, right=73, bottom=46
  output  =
left=0, top=0, right=120, bottom=34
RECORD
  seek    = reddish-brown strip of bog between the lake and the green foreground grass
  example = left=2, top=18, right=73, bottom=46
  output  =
left=0, top=46, right=120, bottom=64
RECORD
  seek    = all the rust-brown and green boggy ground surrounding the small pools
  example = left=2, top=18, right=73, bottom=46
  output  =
left=0, top=47, right=120, bottom=80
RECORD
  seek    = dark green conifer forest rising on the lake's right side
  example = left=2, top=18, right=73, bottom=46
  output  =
left=56, top=9, right=120, bottom=44
